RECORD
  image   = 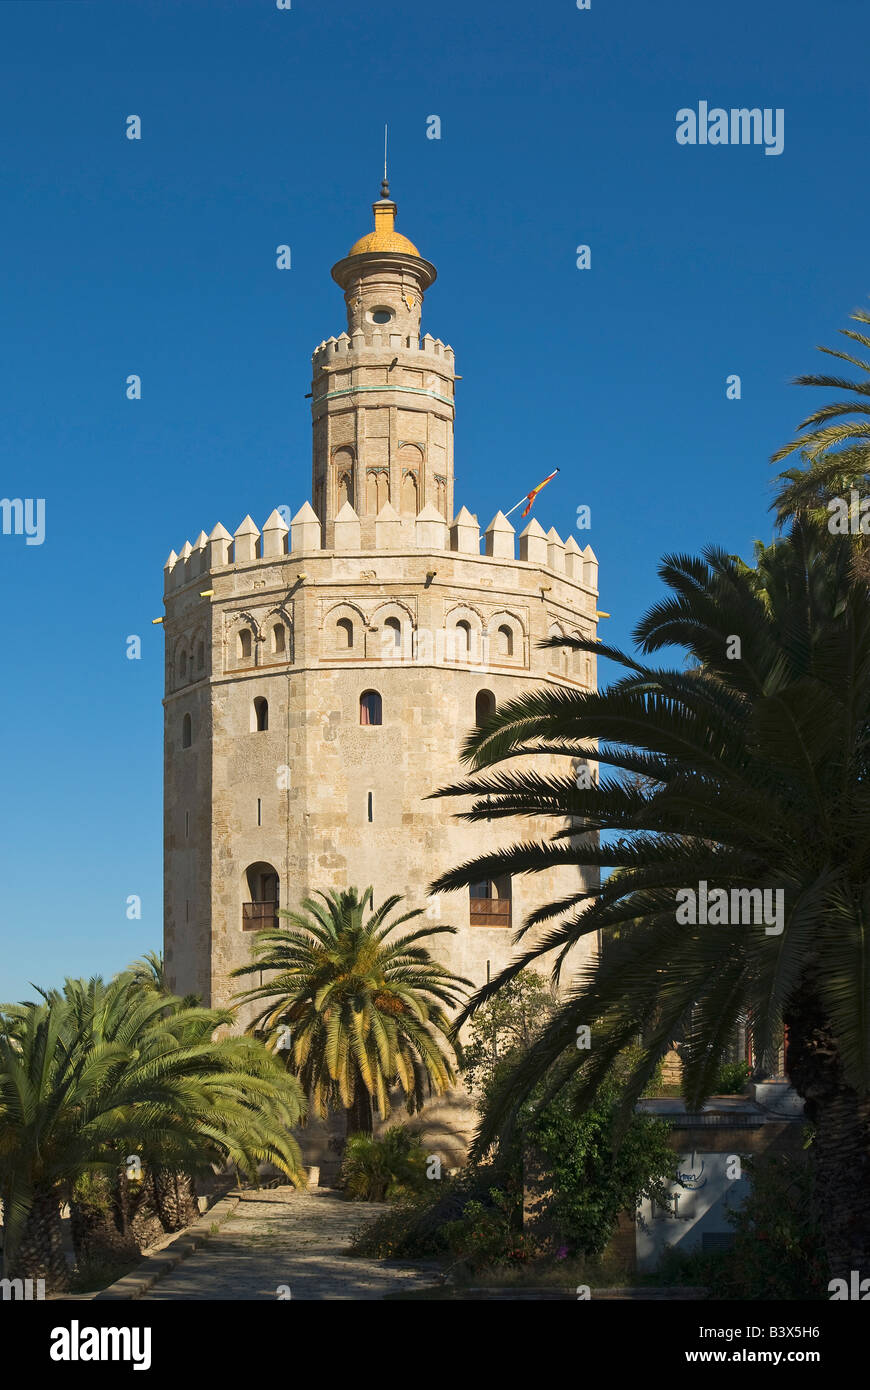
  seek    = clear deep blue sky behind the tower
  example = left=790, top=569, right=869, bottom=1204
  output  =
left=0, top=0, right=870, bottom=998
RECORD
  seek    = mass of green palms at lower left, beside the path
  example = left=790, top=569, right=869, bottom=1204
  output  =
left=0, top=976, right=304, bottom=1289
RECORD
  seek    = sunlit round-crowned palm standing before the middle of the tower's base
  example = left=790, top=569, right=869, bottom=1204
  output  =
left=233, top=888, right=470, bottom=1134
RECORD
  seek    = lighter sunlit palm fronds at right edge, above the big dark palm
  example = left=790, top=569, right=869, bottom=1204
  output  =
left=771, top=309, right=870, bottom=521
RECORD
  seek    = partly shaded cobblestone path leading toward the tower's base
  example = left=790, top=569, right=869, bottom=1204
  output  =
left=142, top=1187, right=438, bottom=1301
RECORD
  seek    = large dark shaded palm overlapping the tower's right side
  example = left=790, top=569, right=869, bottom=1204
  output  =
left=431, top=523, right=870, bottom=1275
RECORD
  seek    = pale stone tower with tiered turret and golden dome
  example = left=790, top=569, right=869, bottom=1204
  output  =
left=164, top=185, right=598, bottom=1156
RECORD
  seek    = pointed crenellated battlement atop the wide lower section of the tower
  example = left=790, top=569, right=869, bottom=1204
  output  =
left=164, top=502, right=598, bottom=594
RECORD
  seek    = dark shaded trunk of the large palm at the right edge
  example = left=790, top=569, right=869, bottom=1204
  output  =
left=785, top=986, right=870, bottom=1280
